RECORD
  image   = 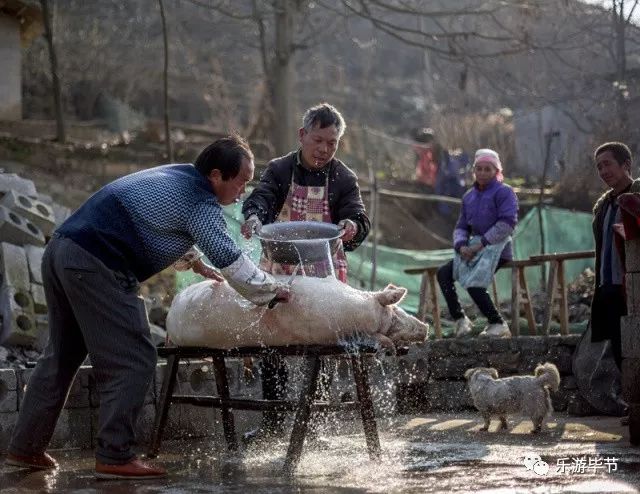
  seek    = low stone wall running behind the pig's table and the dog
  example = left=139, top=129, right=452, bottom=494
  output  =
left=0, top=335, right=582, bottom=453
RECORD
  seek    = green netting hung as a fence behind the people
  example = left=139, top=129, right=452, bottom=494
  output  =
left=176, top=204, right=594, bottom=332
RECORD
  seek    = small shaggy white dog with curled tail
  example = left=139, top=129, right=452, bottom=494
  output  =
left=464, top=362, right=560, bottom=432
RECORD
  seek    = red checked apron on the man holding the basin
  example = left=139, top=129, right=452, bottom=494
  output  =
left=260, top=173, right=347, bottom=283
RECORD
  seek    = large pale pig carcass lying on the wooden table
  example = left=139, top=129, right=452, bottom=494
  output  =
left=167, top=276, right=428, bottom=349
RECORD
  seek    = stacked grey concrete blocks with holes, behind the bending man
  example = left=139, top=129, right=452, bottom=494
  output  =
left=0, top=173, right=68, bottom=347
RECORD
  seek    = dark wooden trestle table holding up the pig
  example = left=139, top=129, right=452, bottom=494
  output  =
left=148, top=345, right=380, bottom=474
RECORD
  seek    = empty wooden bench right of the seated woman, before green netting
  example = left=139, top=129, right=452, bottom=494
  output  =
left=530, top=250, right=595, bottom=335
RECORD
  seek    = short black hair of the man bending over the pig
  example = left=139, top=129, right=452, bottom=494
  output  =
left=193, top=134, right=253, bottom=180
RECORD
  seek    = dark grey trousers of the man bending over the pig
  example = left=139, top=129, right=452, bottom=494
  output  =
left=9, top=237, right=157, bottom=464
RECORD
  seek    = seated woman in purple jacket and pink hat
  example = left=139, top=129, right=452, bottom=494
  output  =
left=438, top=149, right=518, bottom=338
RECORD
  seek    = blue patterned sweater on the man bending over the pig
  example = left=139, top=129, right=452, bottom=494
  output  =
left=57, top=164, right=240, bottom=281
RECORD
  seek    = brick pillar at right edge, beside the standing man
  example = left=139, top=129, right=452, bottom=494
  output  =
left=621, top=235, right=640, bottom=446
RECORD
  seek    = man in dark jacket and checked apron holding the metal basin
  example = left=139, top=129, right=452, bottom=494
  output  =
left=241, top=103, right=371, bottom=438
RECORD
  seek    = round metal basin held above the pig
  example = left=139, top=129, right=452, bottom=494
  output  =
left=257, top=221, right=340, bottom=264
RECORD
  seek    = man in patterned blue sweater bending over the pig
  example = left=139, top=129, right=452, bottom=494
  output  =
left=6, top=136, right=288, bottom=479
